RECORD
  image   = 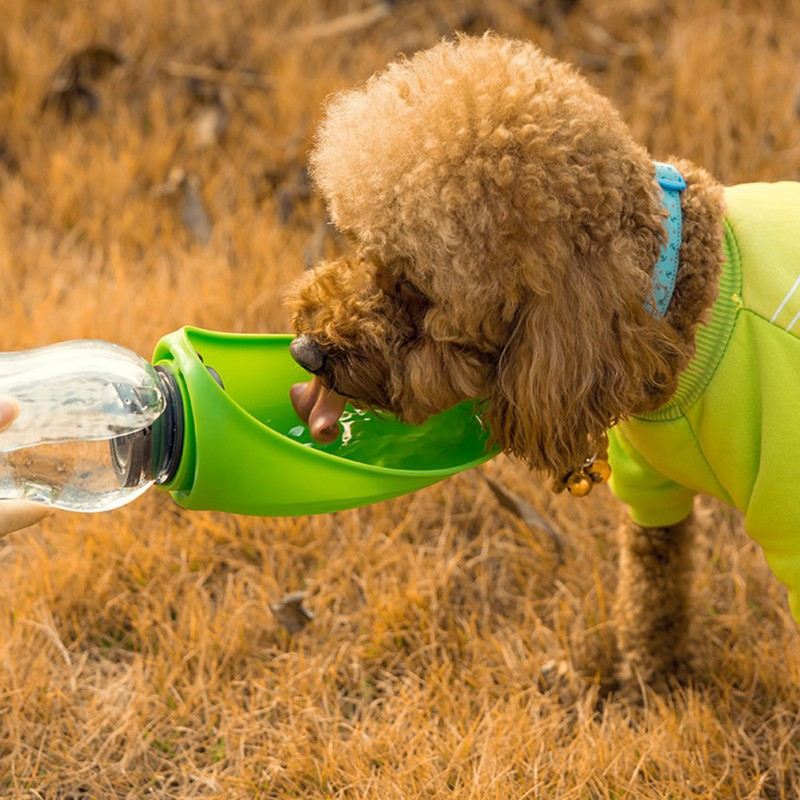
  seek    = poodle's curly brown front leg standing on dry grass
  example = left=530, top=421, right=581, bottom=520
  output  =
left=615, top=517, right=692, bottom=694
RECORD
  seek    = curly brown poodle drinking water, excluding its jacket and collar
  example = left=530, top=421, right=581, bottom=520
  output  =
left=291, top=36, right=800, bottom=685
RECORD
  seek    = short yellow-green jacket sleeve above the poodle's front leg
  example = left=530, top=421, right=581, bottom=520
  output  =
left=608, top=427, right=695, bottom=528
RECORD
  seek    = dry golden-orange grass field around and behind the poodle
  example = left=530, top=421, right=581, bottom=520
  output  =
left=0, top=0, right=800, bottom=800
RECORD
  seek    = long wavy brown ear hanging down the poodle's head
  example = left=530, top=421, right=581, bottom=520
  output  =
left=486, top=265, right=674, bottom=477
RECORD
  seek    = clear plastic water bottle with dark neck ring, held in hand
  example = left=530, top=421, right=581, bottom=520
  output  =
left=0, top=339, right=183, bottom=511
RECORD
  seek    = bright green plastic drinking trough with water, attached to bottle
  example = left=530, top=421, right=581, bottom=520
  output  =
left=153, top=327, right=496, bottom=516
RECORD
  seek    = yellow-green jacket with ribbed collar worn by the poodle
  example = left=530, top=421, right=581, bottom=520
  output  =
left=609, top=182, right=800, bottom=622
